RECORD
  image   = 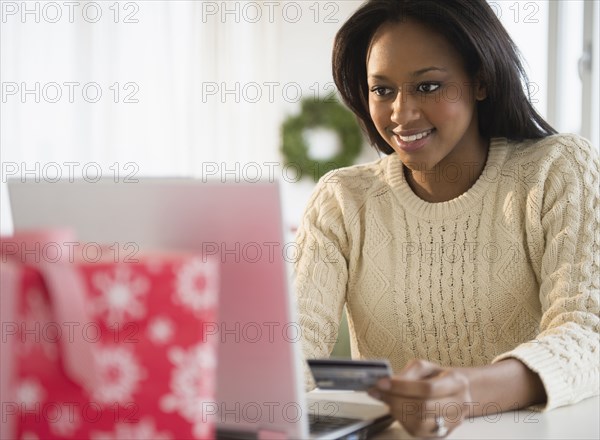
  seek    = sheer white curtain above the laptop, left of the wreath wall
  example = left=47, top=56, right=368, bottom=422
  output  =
left=0, top=1, right=290, bottom=232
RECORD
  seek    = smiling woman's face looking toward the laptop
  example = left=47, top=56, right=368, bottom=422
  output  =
left=367, top=21, right=485, bottom=171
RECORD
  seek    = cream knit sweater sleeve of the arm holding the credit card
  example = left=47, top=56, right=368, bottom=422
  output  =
left=493, top=137, right=600, bottom=410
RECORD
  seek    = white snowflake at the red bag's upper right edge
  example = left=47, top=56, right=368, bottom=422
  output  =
left=173, top=258, right=219, bottom=316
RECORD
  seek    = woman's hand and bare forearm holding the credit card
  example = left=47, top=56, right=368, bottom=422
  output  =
left=369, top=358, right=546, bottom=438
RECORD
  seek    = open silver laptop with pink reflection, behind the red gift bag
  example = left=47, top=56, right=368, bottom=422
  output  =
left=8, top=178, right=392, bottom=439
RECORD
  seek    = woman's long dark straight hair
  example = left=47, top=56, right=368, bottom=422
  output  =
left=332, top=0, right=556, bottom=154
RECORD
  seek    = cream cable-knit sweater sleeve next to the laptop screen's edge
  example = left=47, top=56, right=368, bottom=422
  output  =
left=294, top=175, right=348, bottom=390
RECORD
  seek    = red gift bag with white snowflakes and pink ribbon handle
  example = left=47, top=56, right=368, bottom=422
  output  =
left=0, top=232, right=218, bottom=440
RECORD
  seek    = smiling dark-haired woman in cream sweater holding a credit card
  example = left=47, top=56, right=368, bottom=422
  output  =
left=296, top=0, right=600, bottom=437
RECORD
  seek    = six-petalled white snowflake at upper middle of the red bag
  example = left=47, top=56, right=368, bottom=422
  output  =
left=92, top=265, right=150, bottom=326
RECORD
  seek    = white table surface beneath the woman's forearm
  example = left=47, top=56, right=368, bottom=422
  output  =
left=309, top=391, right=600, bottom=440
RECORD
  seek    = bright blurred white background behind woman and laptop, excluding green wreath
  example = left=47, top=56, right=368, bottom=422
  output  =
left=0, top=0, right=600, bottom=356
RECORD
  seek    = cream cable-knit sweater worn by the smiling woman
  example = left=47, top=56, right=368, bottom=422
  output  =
left=295, top=135, right=600, bottom=409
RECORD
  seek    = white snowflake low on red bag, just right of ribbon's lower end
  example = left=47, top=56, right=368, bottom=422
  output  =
left=89, top=346, right=146, bottom=405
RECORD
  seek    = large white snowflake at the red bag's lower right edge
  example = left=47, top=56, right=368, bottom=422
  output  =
left=160, top=344, right=216, bottom=438
